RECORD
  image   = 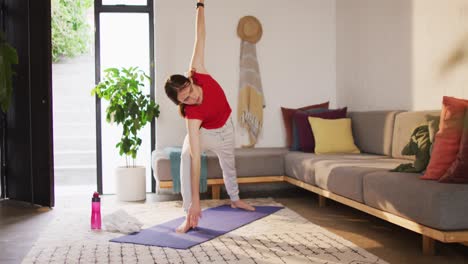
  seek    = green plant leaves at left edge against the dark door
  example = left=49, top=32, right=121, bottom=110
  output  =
left=0, top=32, right=18, bottom=113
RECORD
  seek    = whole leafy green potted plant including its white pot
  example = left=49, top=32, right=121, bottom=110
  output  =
left=91, top=67, right=159, bottom=201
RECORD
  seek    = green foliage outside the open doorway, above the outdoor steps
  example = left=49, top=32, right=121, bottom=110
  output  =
left=51, top=0, right=93, bottom=62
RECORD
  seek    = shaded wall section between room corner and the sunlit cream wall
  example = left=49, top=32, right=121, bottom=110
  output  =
left=336, top=0, right=411, bottom=111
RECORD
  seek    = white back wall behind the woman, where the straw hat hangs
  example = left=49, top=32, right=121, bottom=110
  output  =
left=155, top=0, right=336, bottom=148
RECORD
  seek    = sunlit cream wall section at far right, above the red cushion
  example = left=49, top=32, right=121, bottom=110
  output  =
left=413, top=0, right=468, bottom=109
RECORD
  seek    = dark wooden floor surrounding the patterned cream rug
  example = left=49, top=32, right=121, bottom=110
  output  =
left=0, top=184, right=468, bottom=264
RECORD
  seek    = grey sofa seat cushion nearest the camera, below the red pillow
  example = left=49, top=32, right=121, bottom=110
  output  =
left=363, top=170, right=468, bottom=230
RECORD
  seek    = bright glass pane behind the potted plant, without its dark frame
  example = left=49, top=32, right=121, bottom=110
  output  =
left=100, top=13, right=151, bottom=194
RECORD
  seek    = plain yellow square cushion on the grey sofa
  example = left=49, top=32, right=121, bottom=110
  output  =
left=309, top=117, right=361, bottom=154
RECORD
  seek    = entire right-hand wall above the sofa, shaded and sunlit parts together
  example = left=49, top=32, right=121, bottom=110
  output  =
left=336, top=0, right=468, bottom=110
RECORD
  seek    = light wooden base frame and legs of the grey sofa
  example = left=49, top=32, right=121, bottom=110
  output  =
left=159, top=176, right=468, bottom=255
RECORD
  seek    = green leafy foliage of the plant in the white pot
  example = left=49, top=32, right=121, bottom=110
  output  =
left=91, top=67, right=159, bottom=167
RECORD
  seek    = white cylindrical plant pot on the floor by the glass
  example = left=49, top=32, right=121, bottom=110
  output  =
left=115, top=166, right=146, bottom=202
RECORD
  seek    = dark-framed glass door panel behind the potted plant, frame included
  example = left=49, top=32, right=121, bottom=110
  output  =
left=95, top=0, right=155, bottom=194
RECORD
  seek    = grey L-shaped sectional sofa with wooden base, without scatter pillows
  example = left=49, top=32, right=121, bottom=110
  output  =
left=153, top=111, right=468, bottom=254
